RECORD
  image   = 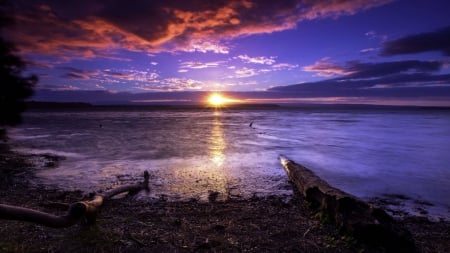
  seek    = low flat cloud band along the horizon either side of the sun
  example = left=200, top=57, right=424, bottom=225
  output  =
left=33, top=84, right=450, bottom=106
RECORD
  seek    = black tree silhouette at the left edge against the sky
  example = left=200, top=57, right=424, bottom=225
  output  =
left=0, top=0, right=38, bottom=138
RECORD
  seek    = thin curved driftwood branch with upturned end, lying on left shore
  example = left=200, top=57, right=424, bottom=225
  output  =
left=0, top=171, right=149, bottom=228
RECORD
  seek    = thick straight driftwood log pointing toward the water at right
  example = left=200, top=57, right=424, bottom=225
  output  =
left=280, top=156, right=416, bottom=252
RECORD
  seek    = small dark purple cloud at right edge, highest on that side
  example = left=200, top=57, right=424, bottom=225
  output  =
left=381, top=26, right=450, bottom=56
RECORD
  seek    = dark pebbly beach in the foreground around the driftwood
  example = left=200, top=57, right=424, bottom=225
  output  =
left=0, top=149, right=450, bottom=252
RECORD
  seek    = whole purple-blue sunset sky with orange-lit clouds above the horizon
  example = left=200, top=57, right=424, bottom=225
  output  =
left=2, top=0, right=450, bottom=106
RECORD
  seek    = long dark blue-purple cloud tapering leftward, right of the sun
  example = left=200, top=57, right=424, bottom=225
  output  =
left=269, top=61, right=450, bottom=97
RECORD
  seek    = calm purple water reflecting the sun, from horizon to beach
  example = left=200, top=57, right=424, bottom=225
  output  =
left=11, top=105, right=450, bottom=216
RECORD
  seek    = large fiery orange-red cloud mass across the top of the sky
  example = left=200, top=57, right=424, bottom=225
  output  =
left=8, top=0, right=391, bottom=59
